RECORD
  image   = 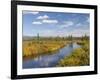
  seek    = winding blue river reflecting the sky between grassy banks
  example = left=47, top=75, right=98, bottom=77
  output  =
left=23, top=43, right=80, bottom=69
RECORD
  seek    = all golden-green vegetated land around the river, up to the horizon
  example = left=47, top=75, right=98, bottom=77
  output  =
left=23, top=35, right=90, bottom=67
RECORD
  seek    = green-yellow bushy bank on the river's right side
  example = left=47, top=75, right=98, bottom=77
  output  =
left=57, top=40, right=90, bottom=67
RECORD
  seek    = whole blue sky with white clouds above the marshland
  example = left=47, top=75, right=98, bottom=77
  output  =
left=22, top=11, right=90, bottom=37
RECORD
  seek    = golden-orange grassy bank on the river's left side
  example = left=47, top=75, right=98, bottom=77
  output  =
left=23, top=40, right=68, bottom=58
